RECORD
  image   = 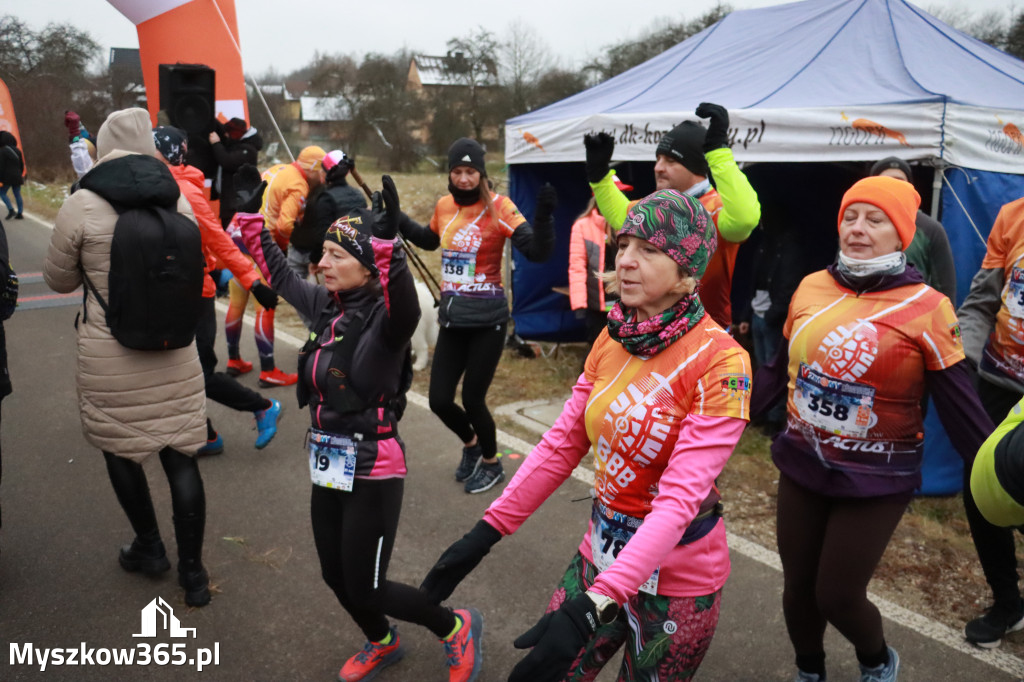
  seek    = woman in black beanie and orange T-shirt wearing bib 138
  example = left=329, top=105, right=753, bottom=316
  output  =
left=401, top=137, right=556, bottom=493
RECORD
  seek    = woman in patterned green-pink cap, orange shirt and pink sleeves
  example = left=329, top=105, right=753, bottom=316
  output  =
left=423, top=189, right=751, bottom=682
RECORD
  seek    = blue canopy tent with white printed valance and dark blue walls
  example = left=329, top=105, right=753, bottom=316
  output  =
left=506, top=0, right=1024, bottom=492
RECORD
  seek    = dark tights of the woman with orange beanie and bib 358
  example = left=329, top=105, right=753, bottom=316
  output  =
left=776, top=474, right=910, bottom=662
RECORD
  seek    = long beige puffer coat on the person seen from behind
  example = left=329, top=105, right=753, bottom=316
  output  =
left=43, top=109, right=206, bottom=461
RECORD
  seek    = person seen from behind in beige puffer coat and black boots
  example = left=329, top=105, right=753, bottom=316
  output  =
left=43, top=109, right=210, bottom=606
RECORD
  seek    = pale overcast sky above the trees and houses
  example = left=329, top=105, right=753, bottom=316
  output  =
left=8, top=0, right=1024, bottom=76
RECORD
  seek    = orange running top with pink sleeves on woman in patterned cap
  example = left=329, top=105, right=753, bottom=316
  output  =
left=483, top=315, right=751, bottom=603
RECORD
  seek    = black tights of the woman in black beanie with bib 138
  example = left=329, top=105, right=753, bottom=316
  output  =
left=430, top=325, right=507, bottom=460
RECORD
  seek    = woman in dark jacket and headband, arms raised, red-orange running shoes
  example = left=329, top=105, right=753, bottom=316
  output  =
left=236, top=175, right=483, bottom=682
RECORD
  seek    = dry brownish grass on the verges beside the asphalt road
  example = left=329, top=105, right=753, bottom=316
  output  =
left=26, top=166, right=1024, bottom=656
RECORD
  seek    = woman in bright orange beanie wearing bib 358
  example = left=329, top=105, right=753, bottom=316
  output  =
left=753, top=176, right=992, bottom=682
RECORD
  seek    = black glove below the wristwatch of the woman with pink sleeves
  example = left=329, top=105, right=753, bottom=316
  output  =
left=509, top=593, right=597, bottom=682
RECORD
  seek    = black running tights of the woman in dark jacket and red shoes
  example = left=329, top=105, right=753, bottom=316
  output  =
left=309, top=478, right=455, bottom=642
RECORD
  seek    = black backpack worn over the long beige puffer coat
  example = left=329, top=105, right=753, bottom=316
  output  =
left=82, top=205, right=206, bottom=350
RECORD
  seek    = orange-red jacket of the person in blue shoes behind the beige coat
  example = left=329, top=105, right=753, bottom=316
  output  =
left=169, top=166, right=259, bottom=298
